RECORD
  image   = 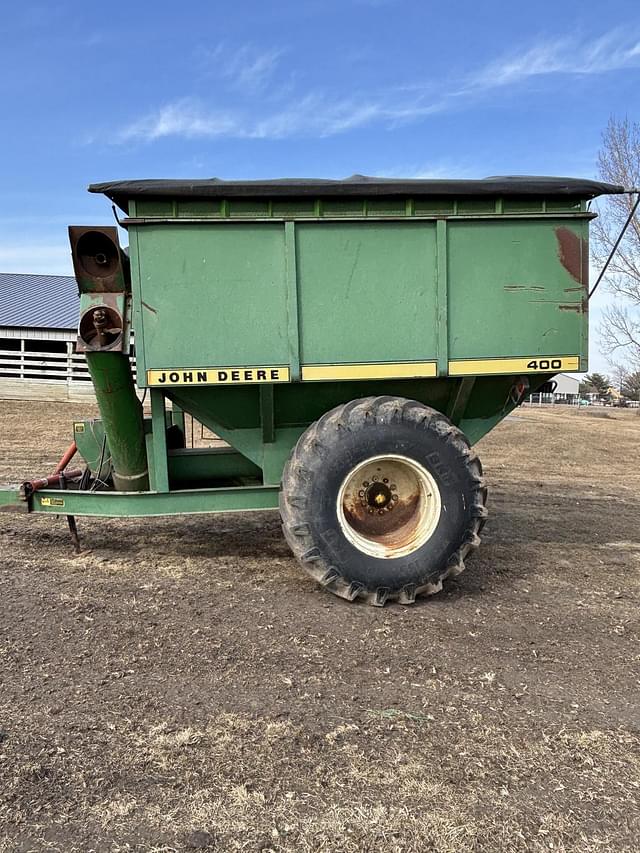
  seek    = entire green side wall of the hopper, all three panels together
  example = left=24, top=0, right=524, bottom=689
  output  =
left=130, top=205, right=590, bottom=385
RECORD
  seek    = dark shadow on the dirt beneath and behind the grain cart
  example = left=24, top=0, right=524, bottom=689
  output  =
left=22, top=487, right=640, bottom=608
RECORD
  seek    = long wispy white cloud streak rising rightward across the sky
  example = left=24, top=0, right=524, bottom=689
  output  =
left=116, top=29, right=640, bottom=142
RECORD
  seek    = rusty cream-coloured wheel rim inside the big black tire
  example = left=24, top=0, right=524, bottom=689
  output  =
left=337, top=454, right=442, bottom=559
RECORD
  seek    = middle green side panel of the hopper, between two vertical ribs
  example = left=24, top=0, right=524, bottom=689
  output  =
left=296, top=222, right=437, bottom=364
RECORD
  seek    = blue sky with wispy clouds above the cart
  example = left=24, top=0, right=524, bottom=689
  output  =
left=0, top=0, right=640, bottom=367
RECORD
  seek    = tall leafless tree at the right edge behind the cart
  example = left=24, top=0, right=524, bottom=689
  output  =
left=593, top=118, right=640, bottom=370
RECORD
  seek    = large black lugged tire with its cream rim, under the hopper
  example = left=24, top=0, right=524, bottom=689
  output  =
left=280, top=397, right=487, bottom=606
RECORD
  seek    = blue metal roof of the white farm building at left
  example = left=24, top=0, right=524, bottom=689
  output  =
left=0, top=273, right=80, bottom=330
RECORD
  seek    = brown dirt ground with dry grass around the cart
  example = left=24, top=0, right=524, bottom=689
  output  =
left=0, top=402, right=640, bottom=853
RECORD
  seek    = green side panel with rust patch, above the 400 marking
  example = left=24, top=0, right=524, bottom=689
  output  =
left=448, top=218, right=588, bottom=359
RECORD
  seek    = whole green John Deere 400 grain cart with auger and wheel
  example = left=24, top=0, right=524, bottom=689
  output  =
left=0, top=176, right=623, bottom=605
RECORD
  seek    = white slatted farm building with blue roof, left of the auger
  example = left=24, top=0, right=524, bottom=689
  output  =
left=0, top=273, right=93, bottom=401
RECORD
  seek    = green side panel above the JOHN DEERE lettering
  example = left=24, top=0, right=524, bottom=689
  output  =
left=134, top=222, right=289, bottom=374
